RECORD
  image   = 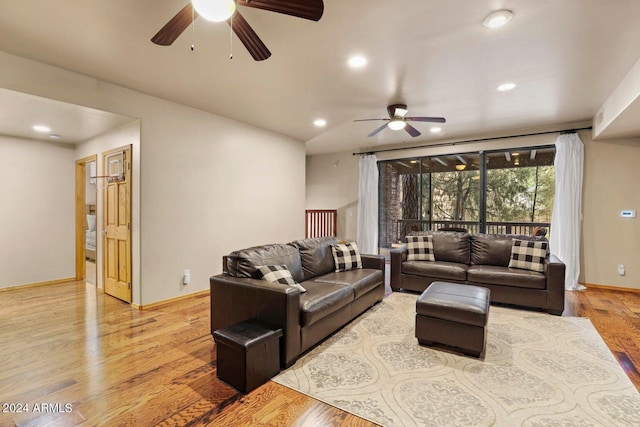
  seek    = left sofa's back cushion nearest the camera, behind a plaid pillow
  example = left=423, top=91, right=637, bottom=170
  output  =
left=227, top=243, right=304, bottom=282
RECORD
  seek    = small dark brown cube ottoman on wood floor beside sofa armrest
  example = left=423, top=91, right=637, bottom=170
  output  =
left=213, top=319, right=282, bottom=393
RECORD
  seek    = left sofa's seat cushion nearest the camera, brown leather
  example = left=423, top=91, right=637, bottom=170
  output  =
left=300, top=280, right=354, bottom=327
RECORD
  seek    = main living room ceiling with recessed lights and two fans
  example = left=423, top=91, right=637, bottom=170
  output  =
left=0, top=0, right=640, bottom=154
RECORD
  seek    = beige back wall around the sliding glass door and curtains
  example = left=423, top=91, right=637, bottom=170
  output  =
left=307, top=131, right=640, bottom=289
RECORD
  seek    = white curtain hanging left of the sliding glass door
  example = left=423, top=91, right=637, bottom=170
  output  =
left=357, top=154, right=378, bottom=254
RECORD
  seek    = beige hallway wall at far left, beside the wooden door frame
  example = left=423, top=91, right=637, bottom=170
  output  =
left=0, top=136, right=76, bottom=288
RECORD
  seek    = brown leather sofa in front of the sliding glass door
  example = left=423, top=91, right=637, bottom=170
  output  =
left=391, top=231, right=565, bottom=315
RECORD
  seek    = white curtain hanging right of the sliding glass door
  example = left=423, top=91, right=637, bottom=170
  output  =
left=549, top=133, right=585, bottom=291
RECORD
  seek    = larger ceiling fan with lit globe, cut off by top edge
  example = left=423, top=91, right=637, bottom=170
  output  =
left=151, top=0, right=324, bottom=61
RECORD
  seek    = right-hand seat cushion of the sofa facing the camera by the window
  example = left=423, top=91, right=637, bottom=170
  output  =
left=467, top=265, right=547, bottom=289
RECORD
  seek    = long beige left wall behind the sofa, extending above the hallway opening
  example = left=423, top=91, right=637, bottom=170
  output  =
left=0, top=52, right=305, bottom=305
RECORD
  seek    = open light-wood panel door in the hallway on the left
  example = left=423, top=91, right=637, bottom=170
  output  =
left=102, top=146, right=131, bottom=303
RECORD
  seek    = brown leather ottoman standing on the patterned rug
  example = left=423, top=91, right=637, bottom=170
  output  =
left=416, top=282, right=490, bottom=357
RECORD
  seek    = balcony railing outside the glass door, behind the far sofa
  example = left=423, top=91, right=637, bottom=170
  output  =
left=395, top=219, right=551, bottom=242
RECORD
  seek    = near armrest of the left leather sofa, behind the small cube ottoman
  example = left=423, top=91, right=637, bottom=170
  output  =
left=209, top=274, right=301, bottom=366
